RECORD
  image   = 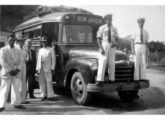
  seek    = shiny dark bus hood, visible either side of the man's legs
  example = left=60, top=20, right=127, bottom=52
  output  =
left=69, top=47, right=128, bottom=61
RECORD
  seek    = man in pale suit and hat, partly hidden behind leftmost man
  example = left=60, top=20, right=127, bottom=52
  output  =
left=16, top=35, right=29, bottom=104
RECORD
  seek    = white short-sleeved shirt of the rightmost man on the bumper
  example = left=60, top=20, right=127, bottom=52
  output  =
left=131, top=28, right=149, bottom=43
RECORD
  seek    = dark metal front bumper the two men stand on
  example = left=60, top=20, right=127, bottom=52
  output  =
left=87, top=80, right=150, bottom=93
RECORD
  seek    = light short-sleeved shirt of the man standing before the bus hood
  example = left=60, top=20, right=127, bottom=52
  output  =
left=97, top=24, right=119, bottom=42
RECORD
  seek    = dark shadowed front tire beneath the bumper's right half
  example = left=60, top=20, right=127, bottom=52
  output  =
left=118, top=90, right=138, bottom=102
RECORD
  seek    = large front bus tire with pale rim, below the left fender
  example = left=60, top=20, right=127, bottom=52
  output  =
left=70, top=72, right=92, bottom=105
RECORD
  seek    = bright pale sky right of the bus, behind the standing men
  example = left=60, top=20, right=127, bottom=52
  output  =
left=79, top=5, right=165, bottom=42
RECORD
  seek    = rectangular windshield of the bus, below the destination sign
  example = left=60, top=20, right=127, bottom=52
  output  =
left=64, top=25, right=93, bottom=43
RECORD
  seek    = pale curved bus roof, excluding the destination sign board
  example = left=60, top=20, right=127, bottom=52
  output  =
left=14, top=12, right=102, bottom=32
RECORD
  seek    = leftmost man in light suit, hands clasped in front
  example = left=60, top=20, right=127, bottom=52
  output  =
left=0, top=35, right=25, bottom=112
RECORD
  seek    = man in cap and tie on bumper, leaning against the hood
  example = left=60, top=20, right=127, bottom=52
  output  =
left=96, top=14, right=118, bottom=86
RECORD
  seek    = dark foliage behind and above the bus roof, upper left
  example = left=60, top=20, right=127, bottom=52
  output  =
left=0, top=5, right=92, bottom=32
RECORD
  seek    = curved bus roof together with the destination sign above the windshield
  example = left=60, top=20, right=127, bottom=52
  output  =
left=14, top=12, right=103, bottom=32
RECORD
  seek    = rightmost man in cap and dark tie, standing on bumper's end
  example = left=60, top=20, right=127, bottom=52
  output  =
left=132, top=18, right=149, bottom=80
